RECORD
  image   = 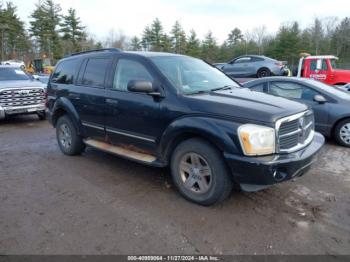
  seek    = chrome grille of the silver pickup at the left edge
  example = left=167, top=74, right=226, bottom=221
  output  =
left=0, top=88, right=45, bottom=107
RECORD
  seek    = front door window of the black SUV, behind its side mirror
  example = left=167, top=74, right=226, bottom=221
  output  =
left=113, top=58, right=153, bottom=91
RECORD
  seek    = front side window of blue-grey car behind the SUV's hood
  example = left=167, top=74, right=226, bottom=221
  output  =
left=269, top=82, right=319, bottom=101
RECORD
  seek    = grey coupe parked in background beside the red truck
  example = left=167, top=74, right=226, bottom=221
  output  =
left=214, top=55, right=289, bottom=78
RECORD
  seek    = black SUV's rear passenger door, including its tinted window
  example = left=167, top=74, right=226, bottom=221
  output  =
left=75, top=56, right=112, bottom=138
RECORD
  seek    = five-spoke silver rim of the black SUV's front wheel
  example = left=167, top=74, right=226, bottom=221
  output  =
left=179, top=153, right=212, bottom=194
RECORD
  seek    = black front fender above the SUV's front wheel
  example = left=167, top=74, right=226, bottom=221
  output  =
left=159, top=116, right=242, bottom=161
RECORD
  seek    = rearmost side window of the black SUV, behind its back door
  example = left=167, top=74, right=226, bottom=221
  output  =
left=52, top=59, right=78, bottom=85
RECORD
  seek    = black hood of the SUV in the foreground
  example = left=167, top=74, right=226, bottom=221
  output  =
left=186, top=88, right=308, bottom=123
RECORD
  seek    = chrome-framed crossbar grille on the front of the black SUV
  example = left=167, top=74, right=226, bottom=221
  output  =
left=276, top=111, right=314, bottom=153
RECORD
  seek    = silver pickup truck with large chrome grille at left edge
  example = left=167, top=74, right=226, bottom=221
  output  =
left=0, top=65, right=46, bottom=120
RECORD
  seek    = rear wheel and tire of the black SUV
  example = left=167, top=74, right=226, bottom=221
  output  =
left=56, top=115, right=85, bottom=156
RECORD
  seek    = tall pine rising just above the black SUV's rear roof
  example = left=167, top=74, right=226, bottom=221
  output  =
left=61, top=8, right=86, bottom=53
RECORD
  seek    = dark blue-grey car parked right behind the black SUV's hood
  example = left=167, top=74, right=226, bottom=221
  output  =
left=243, top=77, right=350, bottom=147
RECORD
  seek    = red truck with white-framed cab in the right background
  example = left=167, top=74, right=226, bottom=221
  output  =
left=297, top=55, right=350, bottom=86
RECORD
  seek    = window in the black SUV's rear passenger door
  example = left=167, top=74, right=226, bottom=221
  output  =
left=82, top=58, right=110, bottom=87
